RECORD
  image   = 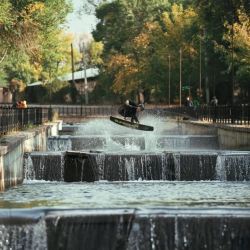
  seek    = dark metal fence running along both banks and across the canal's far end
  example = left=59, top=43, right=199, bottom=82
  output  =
left=0, top=105, right=250, bottom=134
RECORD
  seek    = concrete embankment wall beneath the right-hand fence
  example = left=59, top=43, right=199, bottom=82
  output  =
left=179, top=121, right=250, bottom=151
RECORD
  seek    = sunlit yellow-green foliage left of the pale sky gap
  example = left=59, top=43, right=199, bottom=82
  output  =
left=0, top=0, right=74, bottom=102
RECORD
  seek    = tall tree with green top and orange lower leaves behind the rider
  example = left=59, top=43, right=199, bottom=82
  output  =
left=92, top=0, right=169, bottom=102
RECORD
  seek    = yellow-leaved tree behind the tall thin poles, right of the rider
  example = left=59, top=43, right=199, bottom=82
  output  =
left=147, top=4, right=199, bottom=103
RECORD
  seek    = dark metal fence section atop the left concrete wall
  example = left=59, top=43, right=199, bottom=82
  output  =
left=0, top=107, right=49, bottom=135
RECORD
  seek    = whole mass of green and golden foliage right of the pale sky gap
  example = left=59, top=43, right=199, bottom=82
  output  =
left=88, top=0, right=250, bottom=104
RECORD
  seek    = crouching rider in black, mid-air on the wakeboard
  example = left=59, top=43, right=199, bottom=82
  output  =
left=118, top=100, right=144, bottom=123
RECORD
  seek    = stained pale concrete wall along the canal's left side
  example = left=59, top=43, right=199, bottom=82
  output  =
left=0, top=121, right=62, bottom=190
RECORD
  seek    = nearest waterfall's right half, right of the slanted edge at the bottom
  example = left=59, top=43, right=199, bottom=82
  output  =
left=127, top=211, right=250, bottom=250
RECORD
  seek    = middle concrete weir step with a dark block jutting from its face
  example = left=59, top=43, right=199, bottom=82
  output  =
left=25, top=151, right=250, bottom=182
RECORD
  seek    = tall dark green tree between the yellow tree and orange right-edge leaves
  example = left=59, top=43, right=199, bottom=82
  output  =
left=194, top=0, right=250, bottom=103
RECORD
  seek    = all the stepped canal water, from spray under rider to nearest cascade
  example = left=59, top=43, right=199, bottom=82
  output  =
left=0, top=115, right=250, bottom=250
